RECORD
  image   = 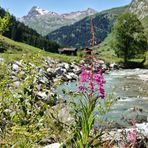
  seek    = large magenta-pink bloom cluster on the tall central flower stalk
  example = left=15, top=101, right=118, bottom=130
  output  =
left=79, top=67, right=105, bottom=98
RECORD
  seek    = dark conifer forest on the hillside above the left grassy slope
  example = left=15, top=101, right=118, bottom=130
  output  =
left=0, top=7, right=59, bottom=52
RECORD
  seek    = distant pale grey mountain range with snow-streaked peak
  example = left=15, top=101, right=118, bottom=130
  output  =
left=19, top=6, right=97, bottom=35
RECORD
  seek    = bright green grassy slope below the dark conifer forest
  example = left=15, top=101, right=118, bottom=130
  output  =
left=0, top=35, right=77, bottom=62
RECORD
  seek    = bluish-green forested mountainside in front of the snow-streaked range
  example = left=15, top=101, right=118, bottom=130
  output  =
left=48, top=6, right=127, bottom=48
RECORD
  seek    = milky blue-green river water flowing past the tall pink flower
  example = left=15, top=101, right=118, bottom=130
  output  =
left=59, top=69, right=148, bottom=126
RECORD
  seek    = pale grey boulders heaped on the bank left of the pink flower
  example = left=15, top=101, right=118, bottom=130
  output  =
left=8, top=58, right=80, bottom=102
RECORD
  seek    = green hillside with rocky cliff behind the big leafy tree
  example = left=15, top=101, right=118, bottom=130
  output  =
left=95, top=0, right=148, bottom=67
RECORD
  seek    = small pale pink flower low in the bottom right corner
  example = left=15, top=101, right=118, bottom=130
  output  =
left=127, top=130, right=137, bottom=144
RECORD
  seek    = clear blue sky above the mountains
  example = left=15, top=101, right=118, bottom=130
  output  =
left=0, top=0, right=132, bottom=17
